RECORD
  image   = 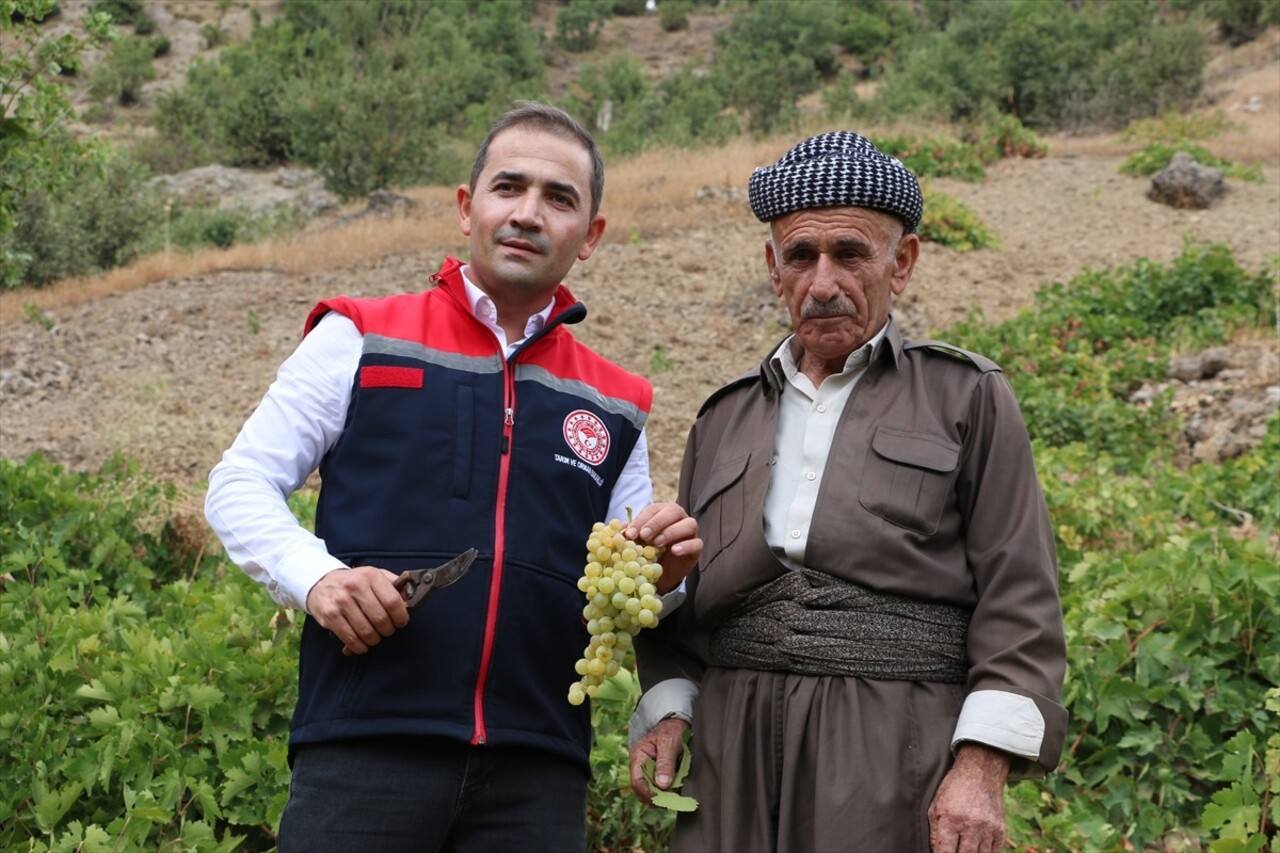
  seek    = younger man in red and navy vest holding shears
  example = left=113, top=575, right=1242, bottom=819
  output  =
left=206, top=104, right=700, bottom=853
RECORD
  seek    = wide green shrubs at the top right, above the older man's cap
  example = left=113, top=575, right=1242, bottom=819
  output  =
left=876, top=0, right=1207, bottom=128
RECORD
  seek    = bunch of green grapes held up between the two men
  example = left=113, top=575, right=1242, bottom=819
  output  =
left=568, top=511, right=662, bottom=704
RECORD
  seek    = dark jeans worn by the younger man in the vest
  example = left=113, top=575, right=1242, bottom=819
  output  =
left=278, top=738, right=586, bottom=853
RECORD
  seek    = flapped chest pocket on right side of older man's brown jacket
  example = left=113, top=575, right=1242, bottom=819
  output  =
left=859, top=427, right=960, bottom=535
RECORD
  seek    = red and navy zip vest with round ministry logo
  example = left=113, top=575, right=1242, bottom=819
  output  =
left=291, top=257, right=653, bottom=770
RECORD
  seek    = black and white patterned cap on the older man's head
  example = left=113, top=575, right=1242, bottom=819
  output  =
left=748, top=131, right=924, bottom=233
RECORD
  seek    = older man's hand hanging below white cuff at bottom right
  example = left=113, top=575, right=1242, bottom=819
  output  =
left=931, top=743, right=1010, bottom=853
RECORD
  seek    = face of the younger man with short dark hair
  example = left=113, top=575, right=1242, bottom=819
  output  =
left=458, top=127, right=604, bottom=301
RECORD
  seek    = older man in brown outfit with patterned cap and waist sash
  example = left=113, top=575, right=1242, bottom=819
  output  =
left=631, top=132, right=1066, bottom=853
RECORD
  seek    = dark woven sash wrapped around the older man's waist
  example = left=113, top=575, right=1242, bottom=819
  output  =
left=709, top=569, right=972, bottom=684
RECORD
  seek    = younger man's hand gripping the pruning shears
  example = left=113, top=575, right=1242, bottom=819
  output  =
left=307, top=566, right=408, bottom=654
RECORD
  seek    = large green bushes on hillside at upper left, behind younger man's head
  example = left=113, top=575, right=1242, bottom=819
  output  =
left=155, top=1, right=544, bottom=197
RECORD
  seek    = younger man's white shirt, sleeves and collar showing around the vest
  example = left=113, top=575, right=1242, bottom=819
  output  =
left=205, top=266, right=653, bottom=611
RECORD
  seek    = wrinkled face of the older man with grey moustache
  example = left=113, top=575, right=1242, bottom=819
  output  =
left=764, top=207, right=920, bottom=361
